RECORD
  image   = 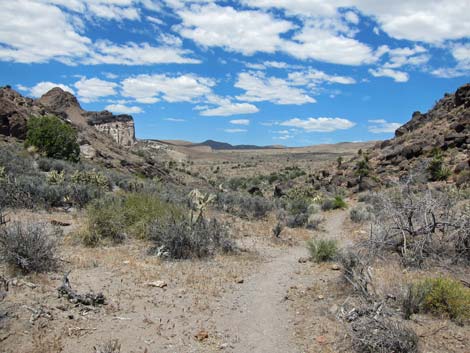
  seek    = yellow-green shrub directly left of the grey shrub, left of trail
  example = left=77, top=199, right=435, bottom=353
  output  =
left=82, top=193, right=181, bottom=245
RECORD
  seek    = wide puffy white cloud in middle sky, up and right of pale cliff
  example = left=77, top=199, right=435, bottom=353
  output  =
left=121, top=74, right=215, bottom=104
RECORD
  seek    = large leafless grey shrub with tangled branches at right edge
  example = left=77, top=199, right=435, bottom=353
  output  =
left=369, top=184, right=470, bottom=267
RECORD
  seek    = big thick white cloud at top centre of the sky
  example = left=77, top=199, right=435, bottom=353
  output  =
left=177, top=4, right=293, bottom=55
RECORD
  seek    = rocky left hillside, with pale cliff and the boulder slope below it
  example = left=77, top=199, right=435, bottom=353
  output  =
left=0, top=86, right=163, bottom=176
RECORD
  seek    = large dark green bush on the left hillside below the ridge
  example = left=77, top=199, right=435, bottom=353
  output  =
left=25, top=116, right=80, bottom=162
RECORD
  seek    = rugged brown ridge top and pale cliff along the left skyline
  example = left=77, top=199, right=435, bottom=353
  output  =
left=0, top=87, right=136, bottom=147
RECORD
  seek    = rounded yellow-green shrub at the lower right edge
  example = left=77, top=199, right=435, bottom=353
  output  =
left=403, top=277, right=470, bottom=322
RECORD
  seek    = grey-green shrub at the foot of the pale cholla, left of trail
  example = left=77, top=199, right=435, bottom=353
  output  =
left=149, top=216, right=235, bottom=259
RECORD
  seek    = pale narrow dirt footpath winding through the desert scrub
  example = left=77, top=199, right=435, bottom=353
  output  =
left=216, top=211, right=346, bottom=353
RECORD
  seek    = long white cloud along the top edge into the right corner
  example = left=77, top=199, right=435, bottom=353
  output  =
left=243, top=0, right=470, bottom=43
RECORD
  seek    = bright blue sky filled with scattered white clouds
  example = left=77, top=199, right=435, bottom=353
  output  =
left=0, top=0, right=470, bottom=146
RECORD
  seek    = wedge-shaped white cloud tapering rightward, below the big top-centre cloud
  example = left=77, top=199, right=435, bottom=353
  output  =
left=235, top=72, right=315, bottom=105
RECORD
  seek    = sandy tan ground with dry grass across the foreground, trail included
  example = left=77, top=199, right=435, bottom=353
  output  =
left=0, top=210, right=470, bottom=353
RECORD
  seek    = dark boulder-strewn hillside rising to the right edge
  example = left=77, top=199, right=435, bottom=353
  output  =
left=326, top=84, right=470, bottom=191
